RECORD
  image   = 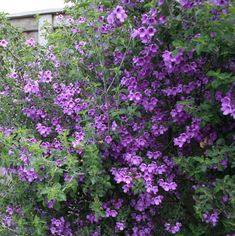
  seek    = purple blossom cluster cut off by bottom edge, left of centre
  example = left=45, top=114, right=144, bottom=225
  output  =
left=50, top=217, right=73, bottom=236
